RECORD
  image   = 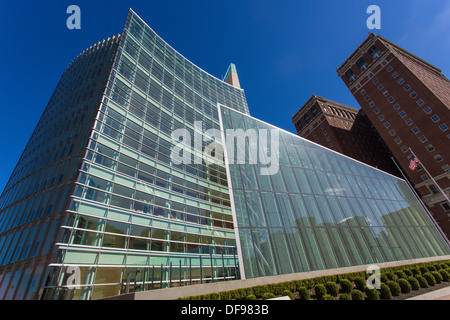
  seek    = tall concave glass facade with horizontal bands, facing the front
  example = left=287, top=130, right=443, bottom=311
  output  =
left=46, top=10, right=248, bottom=299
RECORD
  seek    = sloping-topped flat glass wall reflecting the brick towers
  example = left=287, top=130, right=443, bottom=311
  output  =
left=221, top=107, right=450, bottom=278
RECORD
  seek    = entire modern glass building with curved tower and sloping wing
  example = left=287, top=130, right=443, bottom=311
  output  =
left=0, top=10, right=450, bottom=299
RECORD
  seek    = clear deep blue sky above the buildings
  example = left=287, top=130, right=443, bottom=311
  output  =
left=0, top=0, right=450, bottom=192
